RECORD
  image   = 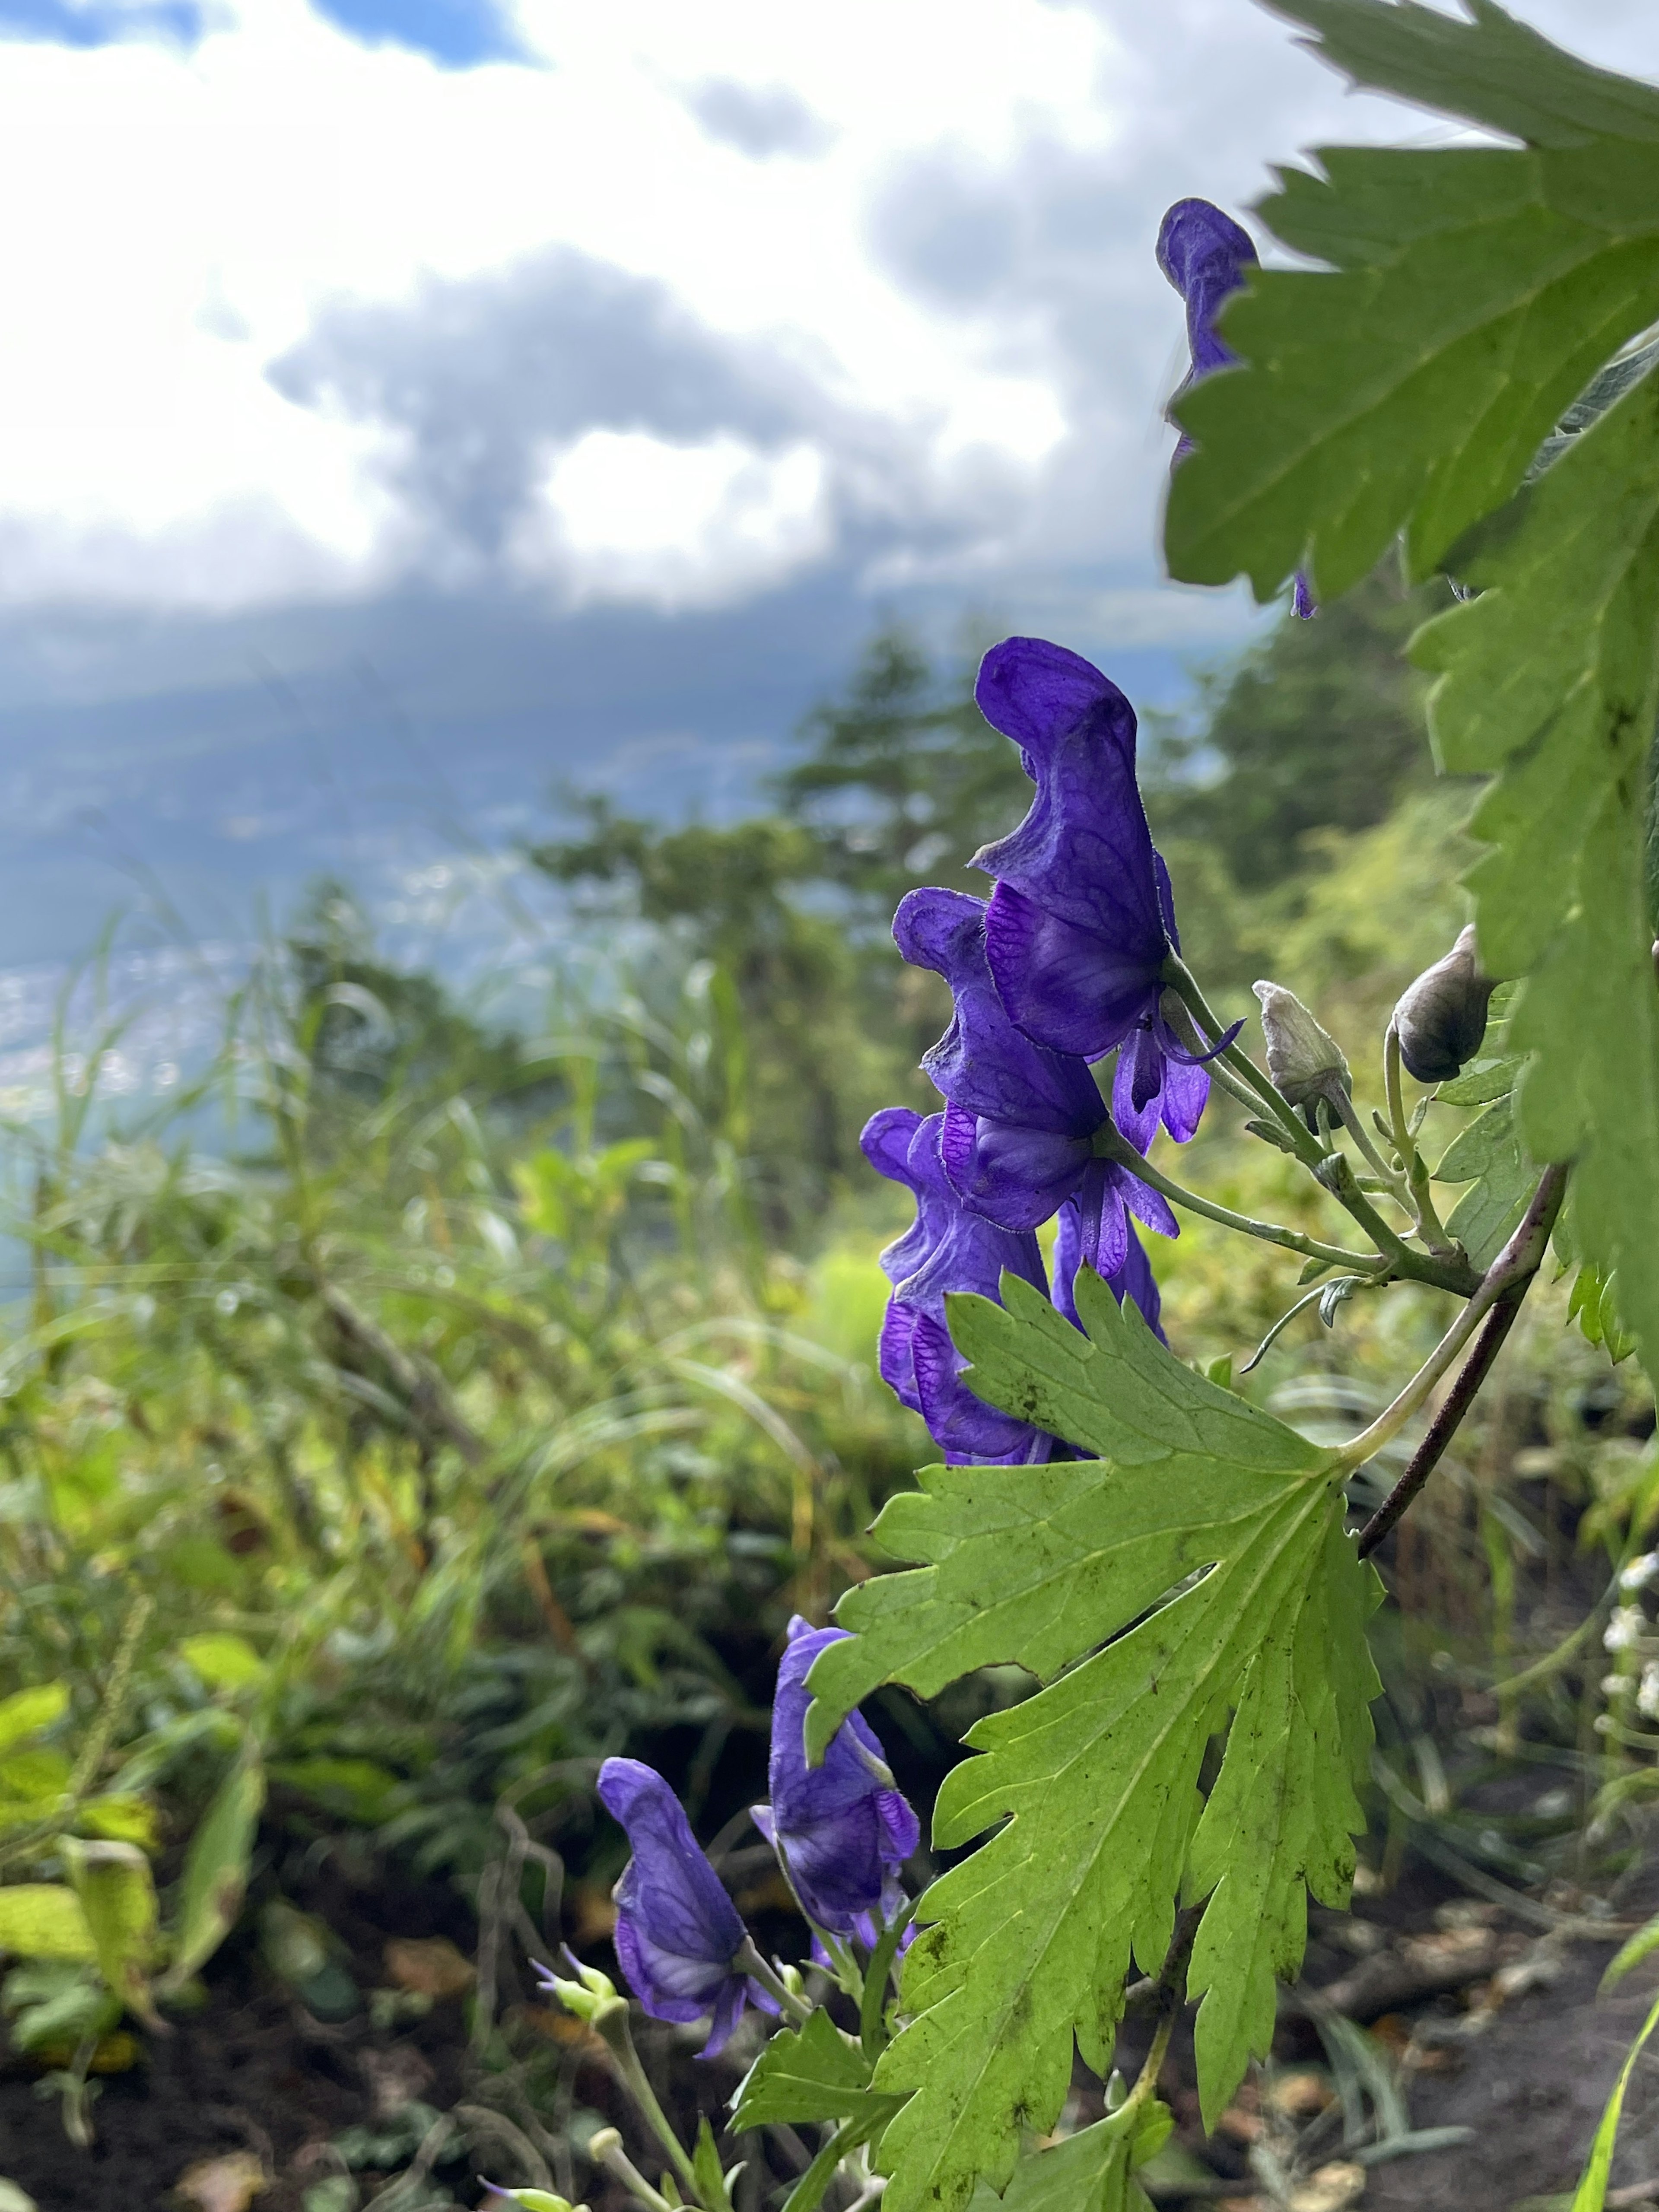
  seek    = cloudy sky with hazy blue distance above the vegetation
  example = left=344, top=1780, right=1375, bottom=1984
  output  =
left=0, top=0, right=1659, bottom=969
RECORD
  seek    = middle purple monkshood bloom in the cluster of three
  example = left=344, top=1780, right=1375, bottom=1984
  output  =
left=893, top=871, right=1181, bottom=1276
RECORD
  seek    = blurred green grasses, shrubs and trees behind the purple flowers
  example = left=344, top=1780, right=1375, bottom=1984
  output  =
left=0, top=562, right=1657, bottom=2212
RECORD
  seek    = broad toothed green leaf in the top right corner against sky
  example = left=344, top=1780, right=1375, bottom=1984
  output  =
left=1166, top=0, right=1659, bottom=600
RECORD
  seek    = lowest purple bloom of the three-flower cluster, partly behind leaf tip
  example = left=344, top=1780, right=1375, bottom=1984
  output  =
left=858, top=1106, right=1055, bottom=1467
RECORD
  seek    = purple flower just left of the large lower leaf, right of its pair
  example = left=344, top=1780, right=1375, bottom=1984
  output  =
left=752, top=1615, right=920, bottom=1944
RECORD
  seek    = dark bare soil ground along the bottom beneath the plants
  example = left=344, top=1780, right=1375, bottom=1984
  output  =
left=0, top=1849, right=1659, bottom=2212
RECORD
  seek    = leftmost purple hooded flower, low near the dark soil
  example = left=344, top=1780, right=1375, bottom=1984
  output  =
left=600, top=1758, right=776, bottom=2057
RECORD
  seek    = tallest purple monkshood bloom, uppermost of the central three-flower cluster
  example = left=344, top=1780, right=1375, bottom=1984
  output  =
left=973, top=637, right=1236, bottom=1153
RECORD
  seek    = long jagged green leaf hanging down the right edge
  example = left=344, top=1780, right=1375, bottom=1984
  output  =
left=1414, top=376, right=1659, bottom=1369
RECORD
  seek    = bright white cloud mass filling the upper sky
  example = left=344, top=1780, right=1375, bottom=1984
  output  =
left=0, top=0, right=1653, bottom=608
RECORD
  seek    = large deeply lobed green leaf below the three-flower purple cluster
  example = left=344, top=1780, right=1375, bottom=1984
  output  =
left=807, top=1270, right=1378, bottom=2212
